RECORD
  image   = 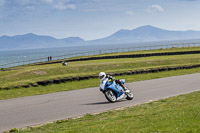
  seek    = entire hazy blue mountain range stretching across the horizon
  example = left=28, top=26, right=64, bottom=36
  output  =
left=0, top=25, right=200, bottom=50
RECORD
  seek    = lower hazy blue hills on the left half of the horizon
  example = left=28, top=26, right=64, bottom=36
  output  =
left=0, top=33, right=85, bottom=50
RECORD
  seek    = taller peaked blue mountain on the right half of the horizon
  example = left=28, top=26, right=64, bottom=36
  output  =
left=90, top=25, right=200, bottom=44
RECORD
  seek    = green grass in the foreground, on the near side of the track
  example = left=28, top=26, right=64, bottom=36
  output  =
left=13, top=92, right=200, bottom=133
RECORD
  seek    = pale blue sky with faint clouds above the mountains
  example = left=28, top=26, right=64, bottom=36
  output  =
left=0, top=0, right=200, bottom=40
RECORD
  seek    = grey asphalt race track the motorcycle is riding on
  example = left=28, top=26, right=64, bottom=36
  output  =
left=0, top=73, right=200, bottom=132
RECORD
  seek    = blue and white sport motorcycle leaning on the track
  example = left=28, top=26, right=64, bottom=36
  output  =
left=103, top=79, right=133, bottom=103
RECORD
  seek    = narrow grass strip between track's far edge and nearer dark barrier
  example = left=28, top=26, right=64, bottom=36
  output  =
left=0, top=68, right=200, bottom=100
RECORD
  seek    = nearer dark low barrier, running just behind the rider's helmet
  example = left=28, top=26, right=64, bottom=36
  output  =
left=0, top=64, right=200, bottom=90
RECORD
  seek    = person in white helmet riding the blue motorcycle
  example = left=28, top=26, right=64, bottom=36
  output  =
left=99, top=72, right=126, bottom=91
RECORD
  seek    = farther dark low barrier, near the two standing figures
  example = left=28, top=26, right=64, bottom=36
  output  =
left=37, top=50, right=200, bottom=65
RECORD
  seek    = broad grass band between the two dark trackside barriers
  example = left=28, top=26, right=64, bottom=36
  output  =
left=0, top=50, right=200, bottom=88
